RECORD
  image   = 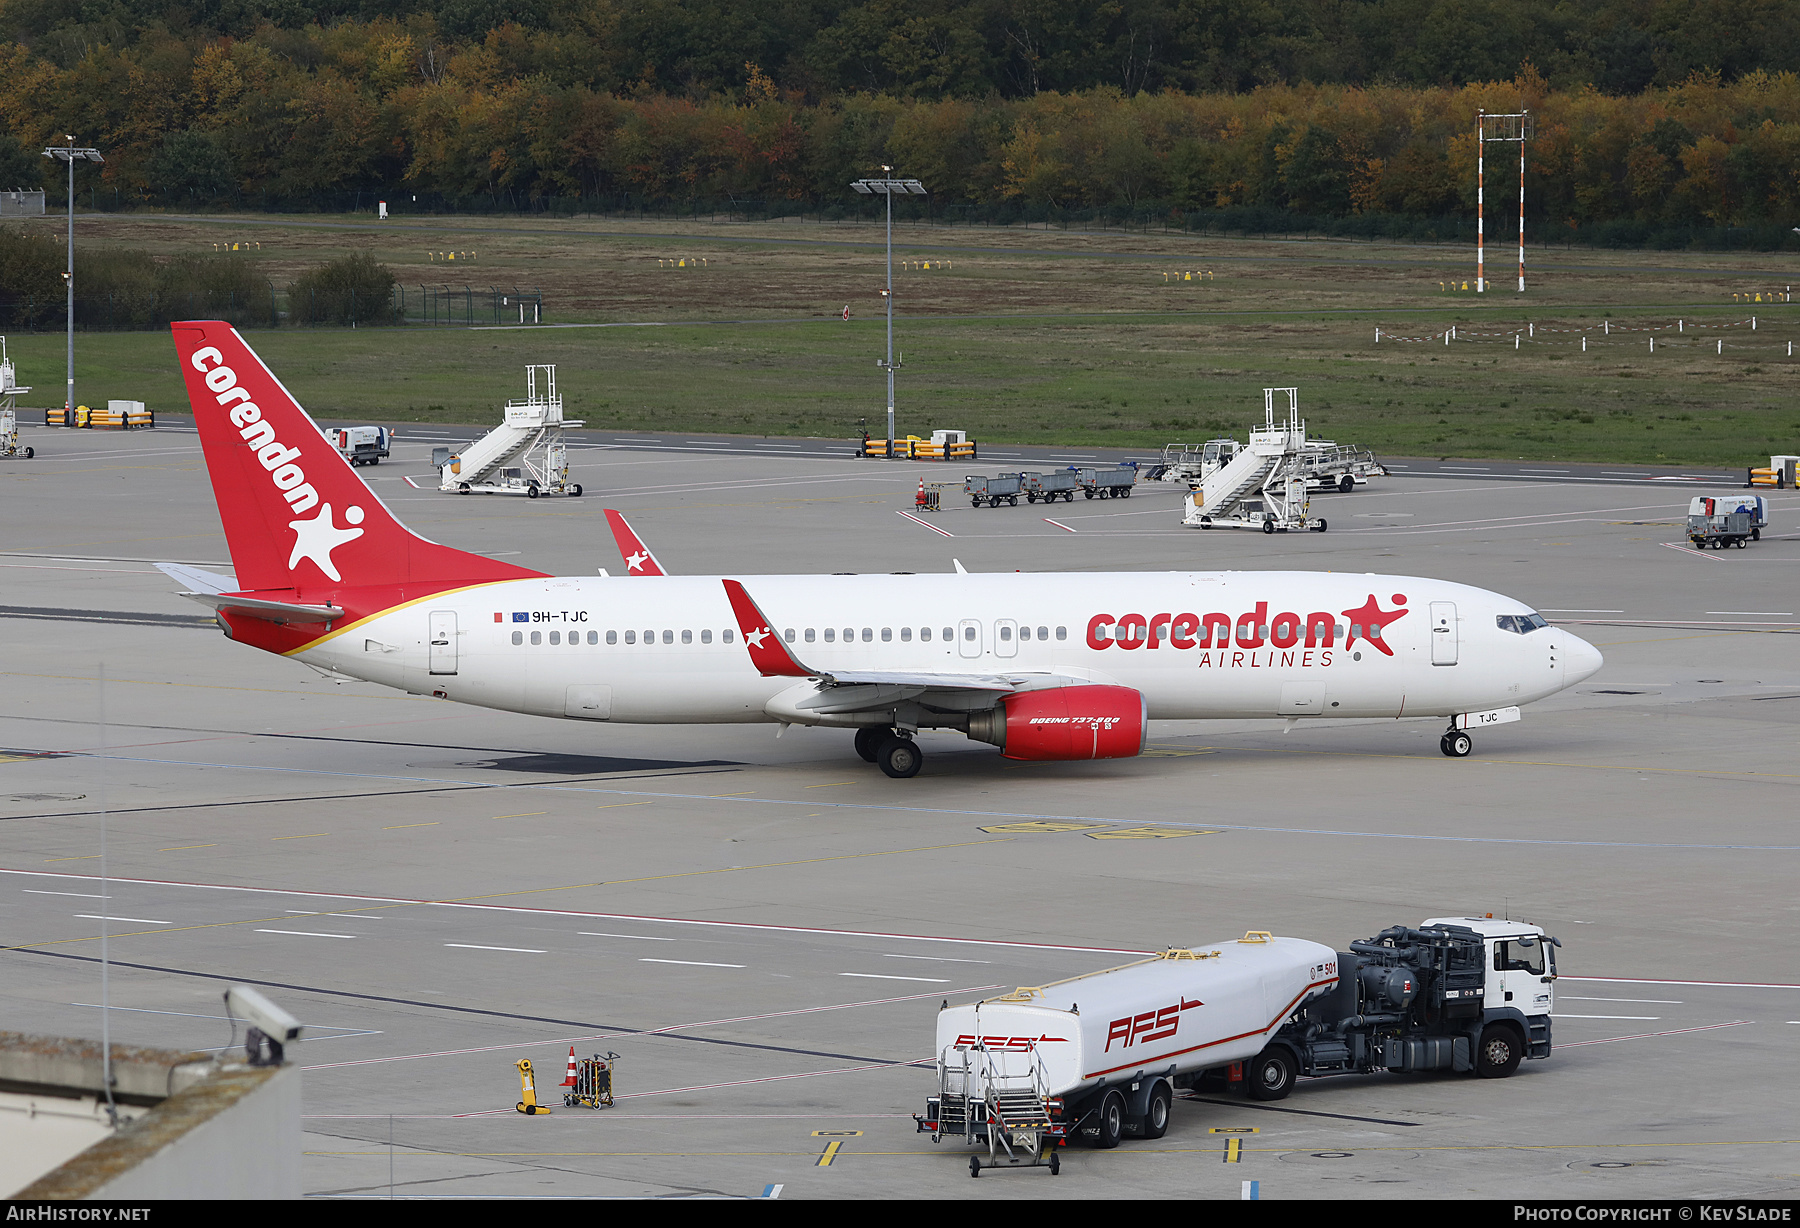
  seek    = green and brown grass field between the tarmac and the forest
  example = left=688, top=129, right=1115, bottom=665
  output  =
left=9, top=216, right=1800, bottom=466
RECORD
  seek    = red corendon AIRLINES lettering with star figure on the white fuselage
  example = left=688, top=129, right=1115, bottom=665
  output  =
left=1087, top=592, right=1408, bottom=668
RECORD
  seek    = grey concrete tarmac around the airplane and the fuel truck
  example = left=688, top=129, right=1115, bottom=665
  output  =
left=0, top=425, right=1800, bottom=1201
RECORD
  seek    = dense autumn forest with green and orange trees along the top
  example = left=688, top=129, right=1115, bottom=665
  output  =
left=0, top=0, right=1800, bottom=247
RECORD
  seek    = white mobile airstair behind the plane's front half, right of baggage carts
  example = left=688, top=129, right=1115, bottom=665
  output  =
left=1181, top=389, right=1325, bottom=533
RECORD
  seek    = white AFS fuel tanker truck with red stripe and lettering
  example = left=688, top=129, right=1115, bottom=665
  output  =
left=914, top=916, right=1561, bottom=1176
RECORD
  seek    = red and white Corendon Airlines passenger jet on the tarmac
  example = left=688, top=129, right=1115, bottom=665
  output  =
left=158, top=321, right=1602, bottom=778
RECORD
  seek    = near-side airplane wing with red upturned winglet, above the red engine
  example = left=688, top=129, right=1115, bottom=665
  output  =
left=724, top=580, right=1089, bottom=715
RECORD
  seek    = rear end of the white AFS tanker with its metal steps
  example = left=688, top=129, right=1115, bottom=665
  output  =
left=932, top=1041, right=1062, bottom=1178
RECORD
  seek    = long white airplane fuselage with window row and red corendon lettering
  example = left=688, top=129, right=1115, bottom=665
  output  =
left=293, top=573, right=1600, bottom=722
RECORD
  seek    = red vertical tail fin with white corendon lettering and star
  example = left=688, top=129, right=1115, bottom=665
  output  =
left=171, top=321, right=542, bottom=591
